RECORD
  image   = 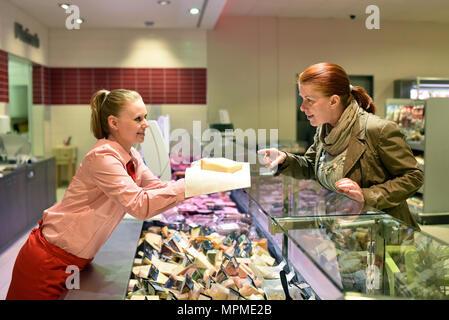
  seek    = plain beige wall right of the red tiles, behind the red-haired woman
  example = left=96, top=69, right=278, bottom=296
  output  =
left=207, top=16, right=449, bottom=140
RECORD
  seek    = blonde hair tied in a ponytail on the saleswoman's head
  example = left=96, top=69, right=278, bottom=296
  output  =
left=90, top=89, right=142, bottom=139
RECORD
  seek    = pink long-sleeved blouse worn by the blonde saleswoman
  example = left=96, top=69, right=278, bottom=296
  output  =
left=42, top=139, right=185, bottom=259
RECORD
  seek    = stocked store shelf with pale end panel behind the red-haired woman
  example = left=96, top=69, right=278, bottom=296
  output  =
left=386, top=97, right=449, bottom=224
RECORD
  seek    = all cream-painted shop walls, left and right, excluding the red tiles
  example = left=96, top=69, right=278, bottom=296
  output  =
left=0, top=1, right=449, bottom=159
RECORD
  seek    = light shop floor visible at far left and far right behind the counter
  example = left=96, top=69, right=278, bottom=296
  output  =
left=0, top=188, right=449, bottom=300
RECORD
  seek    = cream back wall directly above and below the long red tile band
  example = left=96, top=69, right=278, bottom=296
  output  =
left=45, top=27, right=207, bottom=164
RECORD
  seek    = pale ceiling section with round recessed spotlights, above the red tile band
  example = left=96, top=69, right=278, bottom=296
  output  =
left=9, top=0, right=226, bottom=29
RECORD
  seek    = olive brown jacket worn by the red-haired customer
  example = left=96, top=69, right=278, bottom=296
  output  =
left=276, top=110, right=424, bottom=229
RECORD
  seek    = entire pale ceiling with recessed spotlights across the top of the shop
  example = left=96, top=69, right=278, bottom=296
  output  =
left=6, top=0, right=449, bottom=29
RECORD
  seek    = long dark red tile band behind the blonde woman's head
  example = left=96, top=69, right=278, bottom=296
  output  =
left=33, top=65, right=207, bottom=105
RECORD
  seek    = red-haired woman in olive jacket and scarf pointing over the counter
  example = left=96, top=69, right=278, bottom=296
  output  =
left=259, top=62, right=424, bottom=228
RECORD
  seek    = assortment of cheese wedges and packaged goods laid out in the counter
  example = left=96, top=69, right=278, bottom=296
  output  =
left=126, top=192, right=316, bottom=300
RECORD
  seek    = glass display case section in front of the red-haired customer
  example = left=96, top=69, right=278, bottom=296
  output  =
left=233, top=169, right=449, bottom=299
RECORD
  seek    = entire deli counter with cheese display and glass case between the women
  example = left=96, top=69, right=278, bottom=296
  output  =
left=61, top=166, right=449, bottom=300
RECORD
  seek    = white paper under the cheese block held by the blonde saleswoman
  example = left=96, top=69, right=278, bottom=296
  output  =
left=185, top=162, right=251, bottom=197
